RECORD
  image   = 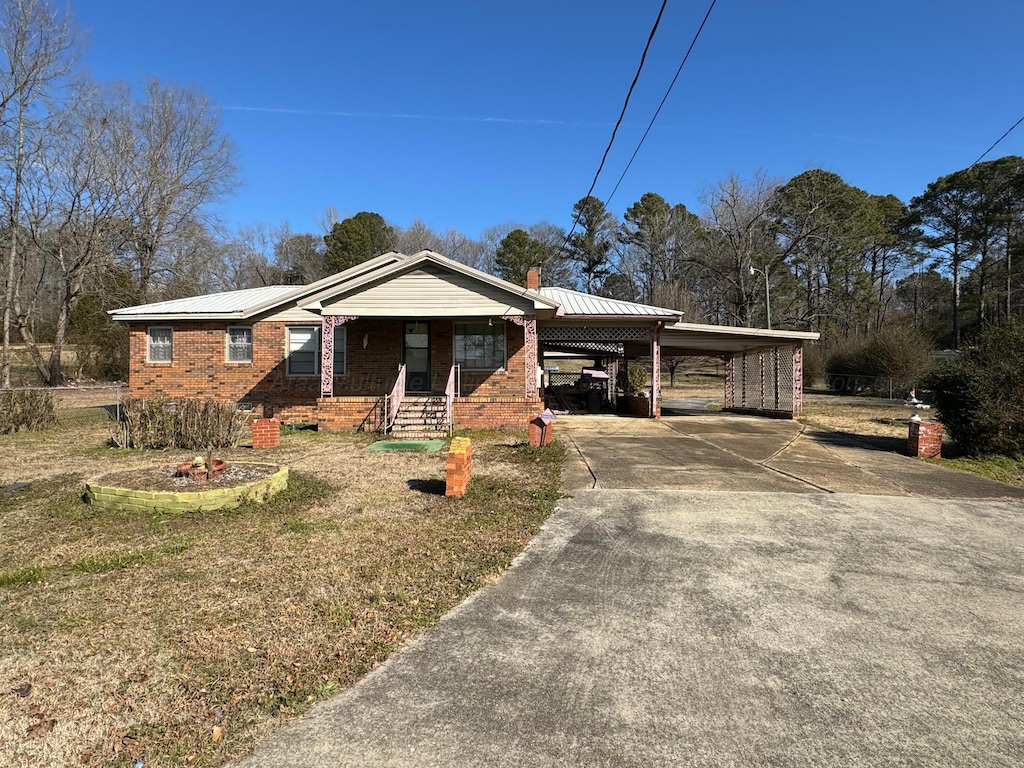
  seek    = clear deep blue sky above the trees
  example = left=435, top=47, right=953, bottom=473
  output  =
left=72, top=0, right=1024, bottom=237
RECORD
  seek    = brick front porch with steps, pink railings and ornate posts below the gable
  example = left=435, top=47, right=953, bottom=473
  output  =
left=316, top=313, right=543, bottom=435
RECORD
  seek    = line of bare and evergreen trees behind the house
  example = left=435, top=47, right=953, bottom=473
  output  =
left=0, top=0, right=1024, bottom=386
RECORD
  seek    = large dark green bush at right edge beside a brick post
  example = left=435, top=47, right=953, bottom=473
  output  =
left=928, top=321, right=1024, bottom=457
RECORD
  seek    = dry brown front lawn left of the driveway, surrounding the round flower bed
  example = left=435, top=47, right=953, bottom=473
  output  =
left=0, top=430, right=562, bottom=768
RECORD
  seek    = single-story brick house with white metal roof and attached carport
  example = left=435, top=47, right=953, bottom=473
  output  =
left=111, top=251, right=817, bottom=431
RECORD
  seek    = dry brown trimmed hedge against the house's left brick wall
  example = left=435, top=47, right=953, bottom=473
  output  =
left=113, top=397, right=248, bottom=451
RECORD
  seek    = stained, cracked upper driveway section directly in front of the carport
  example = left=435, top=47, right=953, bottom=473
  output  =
left=555, top=414, right=1024, bottom=500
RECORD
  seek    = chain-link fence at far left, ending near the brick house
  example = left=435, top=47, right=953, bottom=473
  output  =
left=0, top=384, right=128, bottom=432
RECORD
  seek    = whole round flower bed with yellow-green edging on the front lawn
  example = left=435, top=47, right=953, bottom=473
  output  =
left=85, top=462, right=288, bottom=512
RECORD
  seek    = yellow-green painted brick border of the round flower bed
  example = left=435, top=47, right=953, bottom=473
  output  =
left=85, top=462, right=288, bottom=512
